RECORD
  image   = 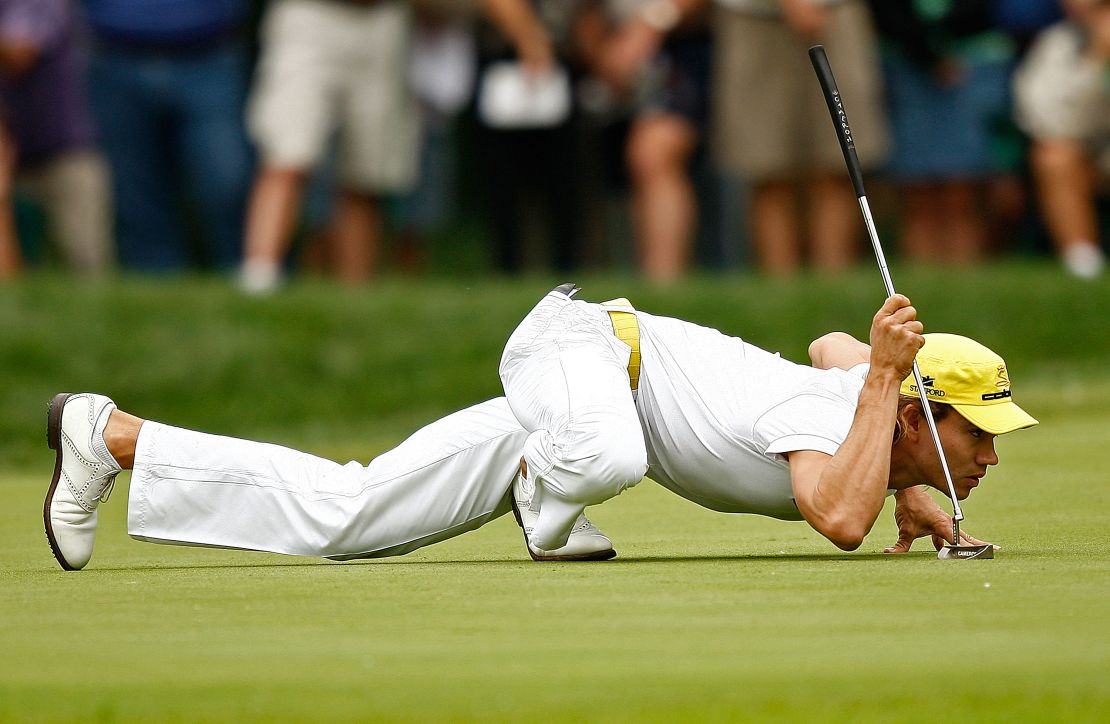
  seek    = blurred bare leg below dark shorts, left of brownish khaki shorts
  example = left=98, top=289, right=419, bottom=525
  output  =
left=626, top=113, right=697, bottom=283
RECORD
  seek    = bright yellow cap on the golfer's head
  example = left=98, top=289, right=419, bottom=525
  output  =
left=900, top=333, right=1037, bottom=435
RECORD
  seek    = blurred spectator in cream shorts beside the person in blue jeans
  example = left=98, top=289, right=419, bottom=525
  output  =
left=241, top=0, right=420, bottom=292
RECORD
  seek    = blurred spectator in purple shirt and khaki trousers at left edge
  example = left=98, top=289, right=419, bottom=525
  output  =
left=0, top=0, right=112, bottom=274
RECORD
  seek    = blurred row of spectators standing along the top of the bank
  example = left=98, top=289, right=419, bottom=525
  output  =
left=0, top=0, right=1110, bottom=286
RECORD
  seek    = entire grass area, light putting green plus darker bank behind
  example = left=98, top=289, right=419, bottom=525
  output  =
left=0, top=264, right=1110, bottom=722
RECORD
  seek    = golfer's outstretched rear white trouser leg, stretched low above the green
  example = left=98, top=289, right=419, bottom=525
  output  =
left=128, top=399, right=527, bottom=560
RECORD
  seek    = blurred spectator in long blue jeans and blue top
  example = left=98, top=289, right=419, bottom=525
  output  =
left=83, top=0, right=252, bottom=272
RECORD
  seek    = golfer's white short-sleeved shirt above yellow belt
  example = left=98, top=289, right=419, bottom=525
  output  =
left=636, top=312, right=868, bottom=520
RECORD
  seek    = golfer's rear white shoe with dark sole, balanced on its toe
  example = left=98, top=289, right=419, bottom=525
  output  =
left=42, top=393, right=120, bottom=571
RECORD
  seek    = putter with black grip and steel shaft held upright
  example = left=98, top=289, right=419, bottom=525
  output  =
left=809, top=46, right=995, bottom=561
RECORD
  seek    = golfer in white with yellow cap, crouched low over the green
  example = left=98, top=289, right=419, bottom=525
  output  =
left=43, top=284, right=1037, bottom=570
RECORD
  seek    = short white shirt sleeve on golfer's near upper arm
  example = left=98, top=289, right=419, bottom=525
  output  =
left=755, top=392, right=856, bottom=455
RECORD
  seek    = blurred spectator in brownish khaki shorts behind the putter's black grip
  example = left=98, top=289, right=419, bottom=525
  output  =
left=713, top=0, right=887, bottom=273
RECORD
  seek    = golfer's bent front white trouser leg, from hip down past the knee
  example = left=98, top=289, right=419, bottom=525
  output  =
left=501, top=290, right=647, bottom=551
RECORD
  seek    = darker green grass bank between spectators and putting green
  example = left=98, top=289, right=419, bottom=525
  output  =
left=0, top=264, right=1110, bottom=466
